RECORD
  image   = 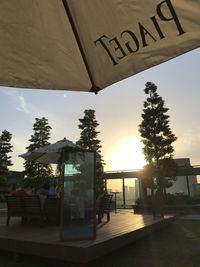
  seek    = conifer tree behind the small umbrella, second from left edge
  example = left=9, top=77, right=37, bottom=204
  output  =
left=24, top=117, right=53, bottom=178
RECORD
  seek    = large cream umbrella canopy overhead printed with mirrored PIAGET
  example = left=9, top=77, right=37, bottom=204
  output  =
left=0, top=0, right=200, bottom=92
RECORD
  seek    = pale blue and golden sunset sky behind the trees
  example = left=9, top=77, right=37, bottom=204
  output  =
left=0, top=49, right=200, bottom=171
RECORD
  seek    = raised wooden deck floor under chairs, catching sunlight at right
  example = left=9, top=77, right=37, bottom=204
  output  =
left=0, top=211, right=173, bottom=263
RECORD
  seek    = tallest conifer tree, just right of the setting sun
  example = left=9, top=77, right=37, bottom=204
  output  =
left=139, top=82, right=177, bottom=216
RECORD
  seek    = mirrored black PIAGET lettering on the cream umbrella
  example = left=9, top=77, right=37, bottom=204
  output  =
left=94, top=0, right=185, bottom=65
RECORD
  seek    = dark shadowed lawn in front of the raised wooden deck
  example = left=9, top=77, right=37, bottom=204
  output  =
left=0, top=220, right=200, bottom=267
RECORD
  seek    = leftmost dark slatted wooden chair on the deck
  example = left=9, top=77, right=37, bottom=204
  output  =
left=6, top=196, right=26, bottom=225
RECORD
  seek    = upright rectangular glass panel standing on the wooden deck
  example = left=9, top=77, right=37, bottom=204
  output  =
left=61, top=151, right=95, bottom=240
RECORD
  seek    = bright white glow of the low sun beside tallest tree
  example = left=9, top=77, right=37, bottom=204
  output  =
left=111, top=139, right=146, bottom=170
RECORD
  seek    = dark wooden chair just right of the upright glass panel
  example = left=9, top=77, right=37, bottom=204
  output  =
left=97, top=194, right=113, bottom=223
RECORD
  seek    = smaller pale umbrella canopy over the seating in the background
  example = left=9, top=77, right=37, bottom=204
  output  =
left=19, top=138, right=84, bottom=164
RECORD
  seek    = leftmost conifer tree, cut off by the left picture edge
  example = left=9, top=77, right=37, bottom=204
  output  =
left=0, top=130, right=13, bottom=187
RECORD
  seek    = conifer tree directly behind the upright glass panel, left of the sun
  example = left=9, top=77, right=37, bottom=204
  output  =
left=77, top=109, right=104, bottom=195
